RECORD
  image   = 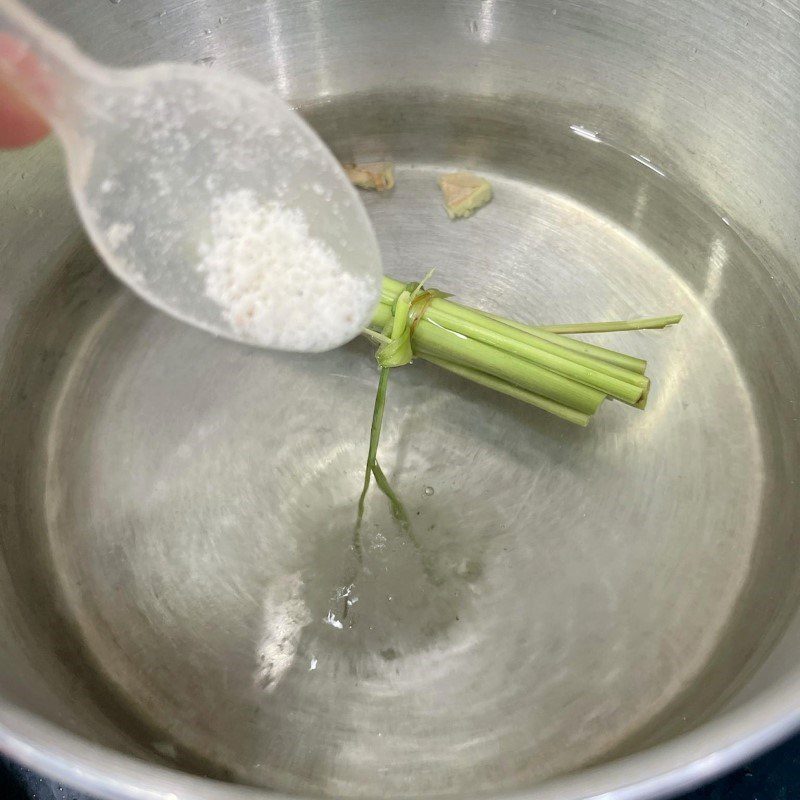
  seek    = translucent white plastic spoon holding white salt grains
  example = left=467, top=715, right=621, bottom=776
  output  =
left=0, top=0, right=381, bottom=351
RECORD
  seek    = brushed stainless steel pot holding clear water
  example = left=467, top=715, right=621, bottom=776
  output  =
left=0, top=0, right=800, bottom=800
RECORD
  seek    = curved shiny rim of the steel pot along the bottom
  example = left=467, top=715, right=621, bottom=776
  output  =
left=0, top=670, right=800, bottom=800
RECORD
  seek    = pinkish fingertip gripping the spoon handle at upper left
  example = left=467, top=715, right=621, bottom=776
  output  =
left=0, top=33, right=49, bottom=149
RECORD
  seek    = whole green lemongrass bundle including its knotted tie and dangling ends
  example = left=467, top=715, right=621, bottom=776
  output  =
left=344, top=272, right=681, bottom=580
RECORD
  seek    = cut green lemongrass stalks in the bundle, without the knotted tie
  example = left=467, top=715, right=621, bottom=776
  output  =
left=365, top=278, right=681, bottom=425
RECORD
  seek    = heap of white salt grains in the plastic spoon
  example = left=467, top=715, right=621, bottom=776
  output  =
left=198, top=189, right=375, bottom=352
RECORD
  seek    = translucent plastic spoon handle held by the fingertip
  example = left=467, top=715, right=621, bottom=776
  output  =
left=0, top=0, right=97, bottom=139
